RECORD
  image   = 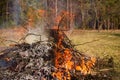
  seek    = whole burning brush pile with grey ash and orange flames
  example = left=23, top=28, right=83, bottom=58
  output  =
left=0, top=30, right=113, bottom=80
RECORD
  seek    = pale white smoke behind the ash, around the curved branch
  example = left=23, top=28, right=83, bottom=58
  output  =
left=25, top=22, right=48, bottom=44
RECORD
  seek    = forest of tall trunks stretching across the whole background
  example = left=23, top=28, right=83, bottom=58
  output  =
left=0, top=0, right=120, bottom=30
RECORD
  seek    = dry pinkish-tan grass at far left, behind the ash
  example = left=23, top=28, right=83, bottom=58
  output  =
left=0, top=27, right=26, bottom=47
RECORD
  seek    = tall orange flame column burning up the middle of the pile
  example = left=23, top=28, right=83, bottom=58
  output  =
left=53, top=29, right=74, bottom=80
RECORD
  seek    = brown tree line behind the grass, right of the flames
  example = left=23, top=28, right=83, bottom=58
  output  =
left=71, top=0, right=120, bottom=30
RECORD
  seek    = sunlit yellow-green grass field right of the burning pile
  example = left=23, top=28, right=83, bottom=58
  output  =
left=69, top=30, right=120, bottom=80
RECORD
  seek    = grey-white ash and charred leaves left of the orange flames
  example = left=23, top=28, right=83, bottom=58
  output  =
left=0, top=42, right=54, bottom=80
